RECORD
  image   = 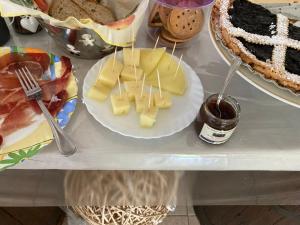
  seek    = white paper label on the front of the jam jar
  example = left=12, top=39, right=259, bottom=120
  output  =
left=199, top=123, right=235, bottom=144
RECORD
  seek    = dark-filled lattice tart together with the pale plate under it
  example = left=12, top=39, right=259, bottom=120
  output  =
left=209, top=0, right=300, bottom=108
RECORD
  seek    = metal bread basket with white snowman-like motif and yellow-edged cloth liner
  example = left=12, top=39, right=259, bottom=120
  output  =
left=0, top=0, right=149, bottom=59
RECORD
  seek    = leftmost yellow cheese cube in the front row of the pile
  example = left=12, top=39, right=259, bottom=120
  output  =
left=110, top=93, right=130, bottom=115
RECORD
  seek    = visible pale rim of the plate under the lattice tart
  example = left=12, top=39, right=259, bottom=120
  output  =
left=208, top=15, right=300, bottom=108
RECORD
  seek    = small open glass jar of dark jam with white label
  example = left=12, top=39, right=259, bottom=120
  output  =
left=195, top=94, right=240, bottom=144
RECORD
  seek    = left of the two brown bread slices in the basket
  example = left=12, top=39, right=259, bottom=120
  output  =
left=49, top=0, right=90, bottom=20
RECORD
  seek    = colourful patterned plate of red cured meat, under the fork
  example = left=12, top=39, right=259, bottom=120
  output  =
left=0, top=47, right=77, bottom=170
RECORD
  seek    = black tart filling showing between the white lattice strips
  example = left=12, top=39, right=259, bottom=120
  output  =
left=229, top=0, right=300, bottom=76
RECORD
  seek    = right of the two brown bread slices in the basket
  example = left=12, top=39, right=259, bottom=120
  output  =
left=72, top=0, right=116, bottom=24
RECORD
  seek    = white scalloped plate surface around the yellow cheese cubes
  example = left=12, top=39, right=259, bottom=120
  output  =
left=83, top=52, right=204, bottom=139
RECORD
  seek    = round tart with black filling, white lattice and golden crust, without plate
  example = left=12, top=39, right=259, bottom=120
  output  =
left=212, top=0, right=300, bottom=92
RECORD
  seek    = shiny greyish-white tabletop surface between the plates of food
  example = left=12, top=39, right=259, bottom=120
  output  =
left=4, top=18, right=300, bottom=171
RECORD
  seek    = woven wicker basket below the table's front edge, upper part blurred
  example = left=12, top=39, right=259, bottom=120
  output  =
left=65, top=171, right=180, bottom=225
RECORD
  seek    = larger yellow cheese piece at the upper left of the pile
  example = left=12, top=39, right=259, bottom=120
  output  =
left=99, top=57, right=123, bottom=88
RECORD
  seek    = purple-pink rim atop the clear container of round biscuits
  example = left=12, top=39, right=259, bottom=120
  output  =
left=157, top=0, right=214, bottom=8
